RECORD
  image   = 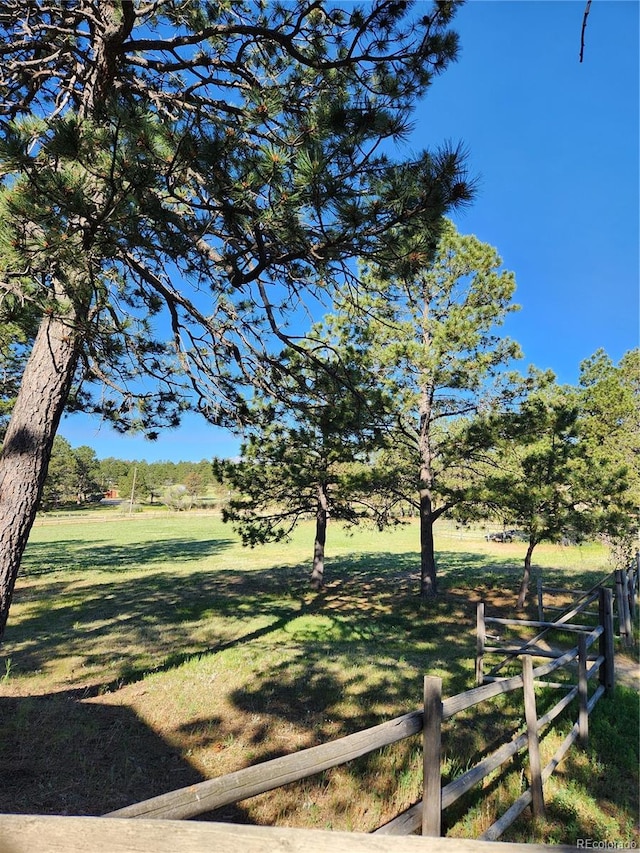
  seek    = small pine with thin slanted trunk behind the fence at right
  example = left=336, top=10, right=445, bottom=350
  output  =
left=484, top=382, right=637, bottom=609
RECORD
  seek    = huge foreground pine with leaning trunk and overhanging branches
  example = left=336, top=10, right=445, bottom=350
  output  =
left=0, top=0, right=470, bottom=634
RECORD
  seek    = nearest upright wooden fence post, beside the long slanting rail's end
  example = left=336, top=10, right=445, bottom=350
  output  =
left=422, top=675, right=442, bottom=837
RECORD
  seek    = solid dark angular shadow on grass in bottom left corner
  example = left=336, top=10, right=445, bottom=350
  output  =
left=0, top=694, right=202, bottom=815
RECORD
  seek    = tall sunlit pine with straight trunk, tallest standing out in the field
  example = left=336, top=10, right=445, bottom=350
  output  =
left=336, top=216, right=520, bottom=597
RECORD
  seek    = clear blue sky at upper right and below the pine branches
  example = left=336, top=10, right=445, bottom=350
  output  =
left=60, top=0, right=640, bottom=461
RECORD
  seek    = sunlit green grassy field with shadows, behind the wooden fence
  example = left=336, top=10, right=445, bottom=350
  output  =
left=0, top=511, right=638, bottom=843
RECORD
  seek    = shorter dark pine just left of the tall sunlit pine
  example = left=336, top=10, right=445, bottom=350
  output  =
left=214, top=336, right=384, bottom=589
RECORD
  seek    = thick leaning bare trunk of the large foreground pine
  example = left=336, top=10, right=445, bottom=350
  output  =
left=0, top=316, right=80, bottom=638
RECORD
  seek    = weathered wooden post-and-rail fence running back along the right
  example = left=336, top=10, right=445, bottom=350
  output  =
left=105, top=589, right=624, bottom=840
